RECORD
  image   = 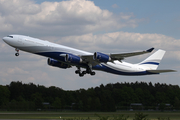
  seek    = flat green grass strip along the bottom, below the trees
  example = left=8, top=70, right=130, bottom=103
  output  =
left=0, top=111, right=180, bottom=120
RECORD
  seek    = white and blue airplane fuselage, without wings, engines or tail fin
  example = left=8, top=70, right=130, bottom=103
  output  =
left=3, top=35, right=153, bottom=75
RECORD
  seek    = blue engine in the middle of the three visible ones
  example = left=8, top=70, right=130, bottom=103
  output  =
left=65, top=54, right=82, bottom=63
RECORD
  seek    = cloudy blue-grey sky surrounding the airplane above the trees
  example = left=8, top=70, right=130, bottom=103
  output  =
left=0, top=0, right=180, bottom=90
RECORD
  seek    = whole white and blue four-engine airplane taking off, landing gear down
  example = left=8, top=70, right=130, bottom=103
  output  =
left=3, top=35, right=175, bottom=77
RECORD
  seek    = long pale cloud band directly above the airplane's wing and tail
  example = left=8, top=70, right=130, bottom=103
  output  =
left=58, top=31, right=180, bottom=52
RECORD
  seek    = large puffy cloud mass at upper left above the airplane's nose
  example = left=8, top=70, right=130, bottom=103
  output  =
left=0, top=0, right=141, bottom=36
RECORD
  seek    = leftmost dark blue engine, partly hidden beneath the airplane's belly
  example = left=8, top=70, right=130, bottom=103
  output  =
left=47, top=58, right=70, bottom=69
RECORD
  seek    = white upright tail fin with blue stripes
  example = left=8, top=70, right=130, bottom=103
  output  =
left=138, top=49, right=166, bottom=70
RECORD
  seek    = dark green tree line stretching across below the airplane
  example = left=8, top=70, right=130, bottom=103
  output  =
left=0, top=81, right=180, bottom=111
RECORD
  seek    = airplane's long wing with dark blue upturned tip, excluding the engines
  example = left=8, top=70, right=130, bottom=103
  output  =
left=80, top=48, right=154, bottom=66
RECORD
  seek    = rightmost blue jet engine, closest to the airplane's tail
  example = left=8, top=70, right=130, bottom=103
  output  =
left=94, top=52, right=111, bottom=63
